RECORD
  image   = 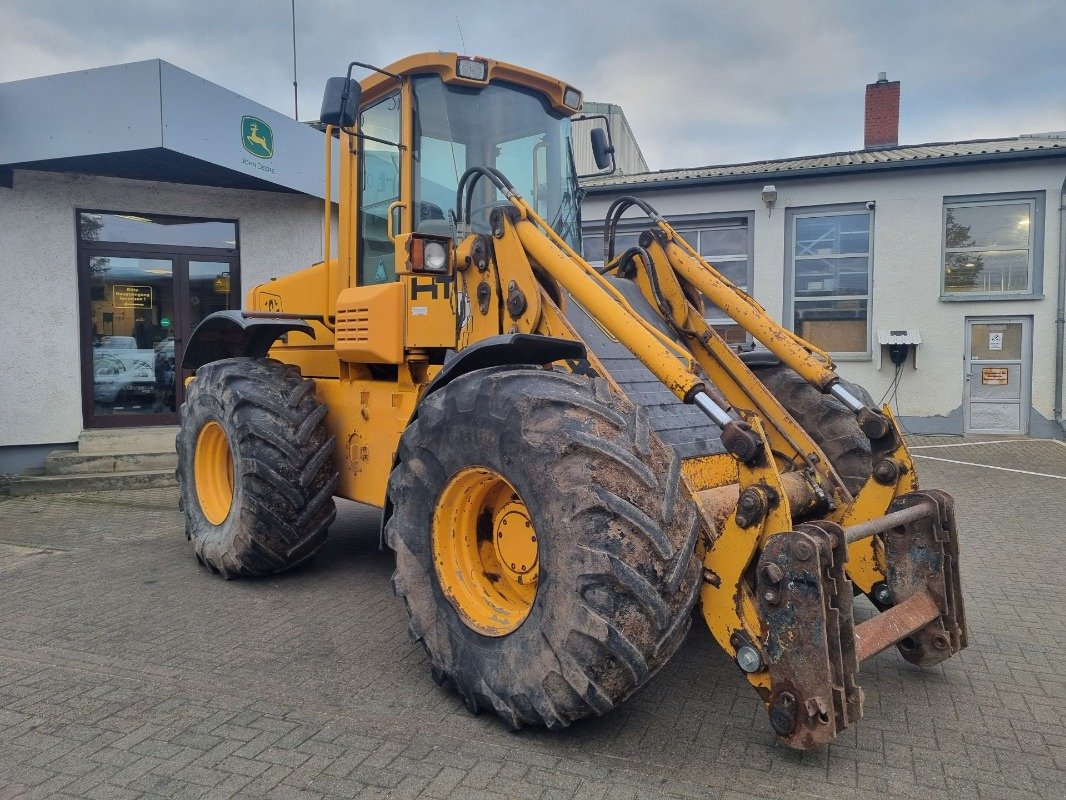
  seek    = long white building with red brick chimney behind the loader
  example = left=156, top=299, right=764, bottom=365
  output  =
left=583, top=79, right=1066, bottom=437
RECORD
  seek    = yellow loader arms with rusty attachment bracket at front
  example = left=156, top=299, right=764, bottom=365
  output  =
left=457, top=170, right=966, bottom=749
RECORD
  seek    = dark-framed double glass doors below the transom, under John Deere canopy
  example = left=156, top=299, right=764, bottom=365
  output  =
left=81, top=249, right=237, bottom=428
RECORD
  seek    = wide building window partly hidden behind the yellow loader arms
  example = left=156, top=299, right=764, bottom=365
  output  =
left=582, top=214, right=752, bottom=345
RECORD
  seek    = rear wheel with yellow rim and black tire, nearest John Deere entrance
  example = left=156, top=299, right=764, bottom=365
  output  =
left=177, top=358, right=337, bottom=578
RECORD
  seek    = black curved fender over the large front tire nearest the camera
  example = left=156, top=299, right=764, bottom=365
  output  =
left=378, top=334, right=587, bottom=550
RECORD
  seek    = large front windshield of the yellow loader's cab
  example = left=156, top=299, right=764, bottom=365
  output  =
left=414, top=76, right=580, bottom=251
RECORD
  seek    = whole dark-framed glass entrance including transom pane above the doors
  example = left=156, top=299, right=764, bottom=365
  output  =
left=78, top=211, right=240, bottom=428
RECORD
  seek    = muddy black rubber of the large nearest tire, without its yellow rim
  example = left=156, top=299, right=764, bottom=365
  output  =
left=385, top=369, right=700, bottom=729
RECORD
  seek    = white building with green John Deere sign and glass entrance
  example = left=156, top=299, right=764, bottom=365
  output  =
left=0, top=61, right=325, bottom=474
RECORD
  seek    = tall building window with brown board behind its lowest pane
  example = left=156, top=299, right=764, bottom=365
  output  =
left=790, top=210, right=872, bottom=356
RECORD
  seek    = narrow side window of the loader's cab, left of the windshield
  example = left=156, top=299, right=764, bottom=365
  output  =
left=359, top=93, right=400, bottom=286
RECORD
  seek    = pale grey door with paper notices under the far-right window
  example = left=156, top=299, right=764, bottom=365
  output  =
left=963, top=317, right=1031, bottom=434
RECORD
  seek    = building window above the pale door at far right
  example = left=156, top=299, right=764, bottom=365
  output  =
left=941, top=195, right=1043, bottom=300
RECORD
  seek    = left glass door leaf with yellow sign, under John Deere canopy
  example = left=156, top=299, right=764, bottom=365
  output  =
left=84, top=255, right=178, bottom=426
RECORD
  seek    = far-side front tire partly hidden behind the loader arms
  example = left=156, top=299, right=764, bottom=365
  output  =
left=754, top=364, right=877, bottom=495
